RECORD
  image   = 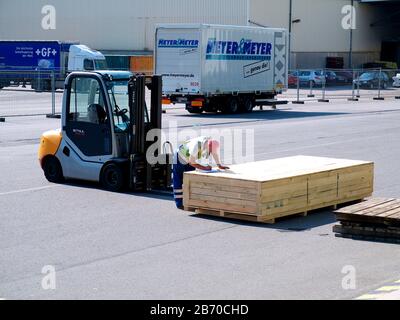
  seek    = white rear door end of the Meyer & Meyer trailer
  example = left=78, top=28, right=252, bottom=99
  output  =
left=155, top=28, right=201, bottom=94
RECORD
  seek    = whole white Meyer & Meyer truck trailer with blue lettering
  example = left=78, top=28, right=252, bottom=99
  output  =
left=154, top=24, right=288, bottom=113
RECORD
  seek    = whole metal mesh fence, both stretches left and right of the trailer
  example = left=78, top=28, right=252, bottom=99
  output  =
left=0, top=69, right=400, bottom=119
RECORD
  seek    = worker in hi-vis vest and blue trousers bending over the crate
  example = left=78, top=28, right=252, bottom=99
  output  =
left=173, top=137, right=229, bottom=209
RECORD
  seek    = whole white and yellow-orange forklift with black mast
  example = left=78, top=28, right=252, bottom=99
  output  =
left=38, top=71, right=172, bottom=192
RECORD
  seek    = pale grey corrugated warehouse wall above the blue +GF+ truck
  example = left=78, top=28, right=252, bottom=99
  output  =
left=0, top=0, right=248, bottom=51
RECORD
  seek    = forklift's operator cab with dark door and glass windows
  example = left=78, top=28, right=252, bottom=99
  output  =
left=63, top=72, right=145, bottom=163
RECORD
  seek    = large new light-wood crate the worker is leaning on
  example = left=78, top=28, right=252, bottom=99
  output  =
left=184, top=156, right=374, bottom=223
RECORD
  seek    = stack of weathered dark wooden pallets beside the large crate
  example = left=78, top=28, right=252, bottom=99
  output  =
left=333, top=198, right=400, bottom=243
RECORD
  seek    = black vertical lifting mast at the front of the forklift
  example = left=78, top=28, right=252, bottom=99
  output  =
left=128, top=75, right=172, bottom=192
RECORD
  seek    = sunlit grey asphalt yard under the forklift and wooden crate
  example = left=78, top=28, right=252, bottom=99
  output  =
left=0, top=94, right=400, bottom=300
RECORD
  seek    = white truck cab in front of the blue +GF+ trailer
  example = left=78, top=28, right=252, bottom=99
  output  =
left=68, top=45, right=107, bottom=72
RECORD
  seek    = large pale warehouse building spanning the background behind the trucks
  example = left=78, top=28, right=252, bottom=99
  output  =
left=0, top=0, right=400, bottom=71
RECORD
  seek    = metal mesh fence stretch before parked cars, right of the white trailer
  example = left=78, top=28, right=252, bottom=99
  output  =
left=280, top=69, right=400, bottom=104
